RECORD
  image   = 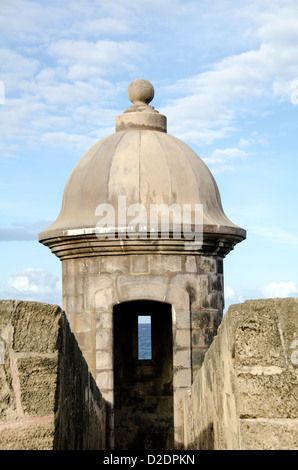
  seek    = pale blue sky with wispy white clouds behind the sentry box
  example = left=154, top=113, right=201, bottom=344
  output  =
left=0, top=0, right=298, bottom=312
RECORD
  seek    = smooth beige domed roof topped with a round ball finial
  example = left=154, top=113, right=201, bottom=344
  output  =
left=39, top=79, right=245, bottom=253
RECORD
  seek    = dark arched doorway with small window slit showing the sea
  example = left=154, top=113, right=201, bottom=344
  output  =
left=113, top=300, right=174, bottom=450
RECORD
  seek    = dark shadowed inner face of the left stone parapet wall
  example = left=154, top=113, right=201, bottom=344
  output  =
left=53, top=314, right=110, bottom=450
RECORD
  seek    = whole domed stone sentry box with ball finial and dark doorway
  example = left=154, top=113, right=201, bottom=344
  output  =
left=39, top=79, right=245, bottom=449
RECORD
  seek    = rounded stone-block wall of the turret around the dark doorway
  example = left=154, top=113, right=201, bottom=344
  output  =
left=60, top=253, right=223, bottom=448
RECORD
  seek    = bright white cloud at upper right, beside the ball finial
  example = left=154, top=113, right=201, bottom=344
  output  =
left=163, top=2, right=298, bottom=144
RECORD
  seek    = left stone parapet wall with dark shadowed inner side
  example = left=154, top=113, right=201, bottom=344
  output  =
left=0, top=300, right=106, bottom=450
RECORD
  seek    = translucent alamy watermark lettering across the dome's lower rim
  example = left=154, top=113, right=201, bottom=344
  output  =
left=95, top=196, right=203, bottom=249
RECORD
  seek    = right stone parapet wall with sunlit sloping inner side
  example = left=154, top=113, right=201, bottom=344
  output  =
left=181, top=298, right=298, bottom=450
